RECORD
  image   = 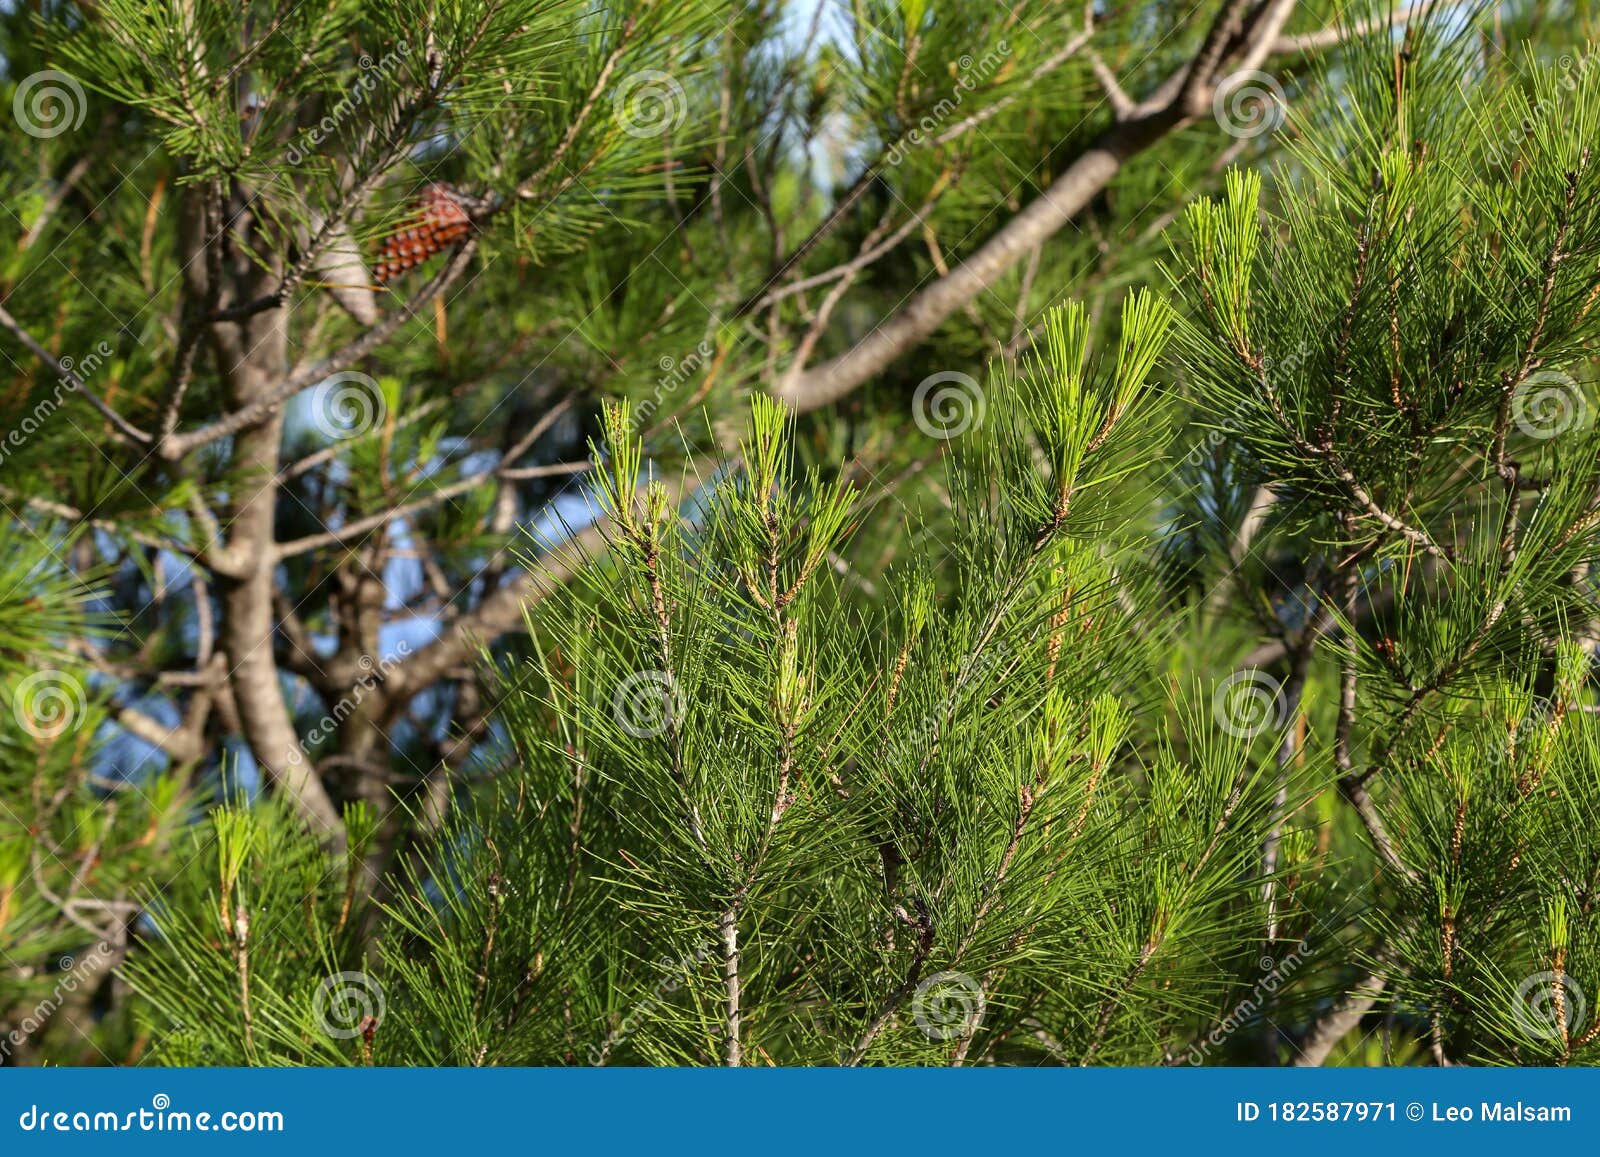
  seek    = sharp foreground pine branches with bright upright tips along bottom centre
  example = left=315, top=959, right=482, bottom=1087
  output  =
left=128, top=293, right=1312, bottom=1064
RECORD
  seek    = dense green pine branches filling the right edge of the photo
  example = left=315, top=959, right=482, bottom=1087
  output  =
left=1173, top=13, right=1600, bottom=1064
